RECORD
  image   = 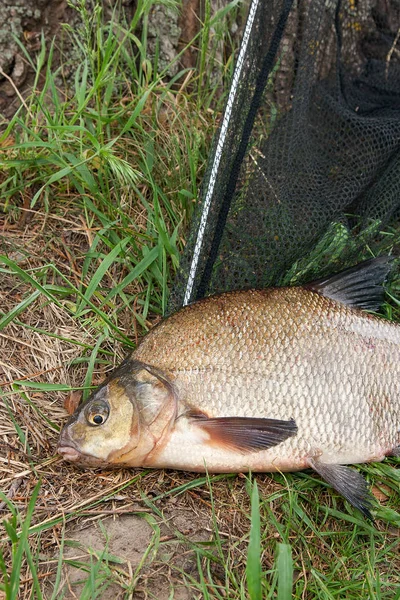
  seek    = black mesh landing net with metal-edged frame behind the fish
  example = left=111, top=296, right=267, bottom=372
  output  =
left=169, top=0, right=400, bottom=311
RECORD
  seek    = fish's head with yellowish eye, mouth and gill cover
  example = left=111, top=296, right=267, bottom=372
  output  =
left=57, top=359, right=176, bottom=467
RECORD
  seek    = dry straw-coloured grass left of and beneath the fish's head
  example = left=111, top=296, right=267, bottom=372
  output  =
left=0, top=212, right=248, bottom=598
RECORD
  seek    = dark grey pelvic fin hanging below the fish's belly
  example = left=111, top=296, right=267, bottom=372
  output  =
left=308, top=458, right=374, bottom=521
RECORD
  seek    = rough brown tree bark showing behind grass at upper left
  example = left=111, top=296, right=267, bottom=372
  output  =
left=0, top=0, right=243, bottom=119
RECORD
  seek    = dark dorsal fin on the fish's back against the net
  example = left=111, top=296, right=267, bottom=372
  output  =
left=304, top=256, right=393, bottom=310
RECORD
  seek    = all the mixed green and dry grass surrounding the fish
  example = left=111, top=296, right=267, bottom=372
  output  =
left=0, top=1, right=400, bottom=600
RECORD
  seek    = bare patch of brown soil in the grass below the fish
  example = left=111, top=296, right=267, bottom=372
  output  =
left=64, top=511, right=210, bottom=600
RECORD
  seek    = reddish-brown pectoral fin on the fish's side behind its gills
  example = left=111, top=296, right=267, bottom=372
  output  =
left=190, top=413, right=297, bottom=452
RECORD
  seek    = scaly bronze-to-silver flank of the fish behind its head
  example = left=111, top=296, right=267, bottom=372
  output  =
left=133, top=288, right=400, bottom=470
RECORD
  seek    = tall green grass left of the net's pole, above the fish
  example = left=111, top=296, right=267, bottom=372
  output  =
left=0, top=2, right=238, bottom=343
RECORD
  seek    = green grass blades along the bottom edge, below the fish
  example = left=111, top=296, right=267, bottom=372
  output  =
left=0, top=475, right=400, bottom=600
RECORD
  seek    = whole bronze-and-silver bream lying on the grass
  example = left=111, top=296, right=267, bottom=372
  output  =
left=58, top=256, right=400, bottom=519
